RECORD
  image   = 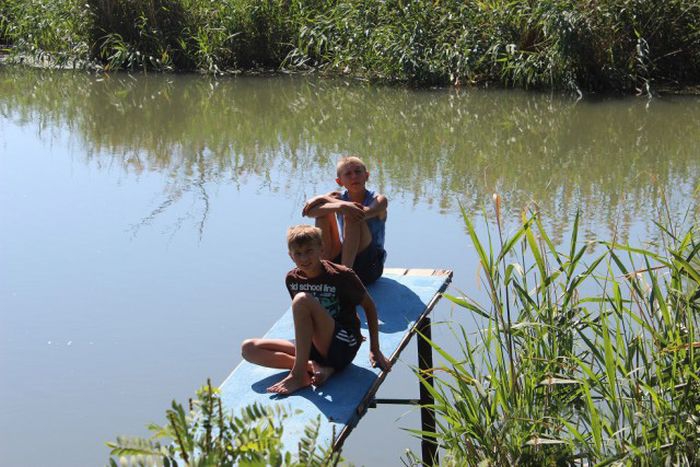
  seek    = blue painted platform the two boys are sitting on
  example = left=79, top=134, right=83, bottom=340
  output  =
left=220, top=269, right=452, bottom=452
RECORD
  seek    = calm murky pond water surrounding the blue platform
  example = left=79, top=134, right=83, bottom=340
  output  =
left=0, top=66, right=700, bottom=466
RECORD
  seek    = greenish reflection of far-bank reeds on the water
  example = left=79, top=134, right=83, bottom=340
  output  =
left=0, top=68, right=700, bottom=238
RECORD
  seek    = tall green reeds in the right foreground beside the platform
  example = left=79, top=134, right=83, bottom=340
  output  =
left=412, top=207, right=700, bottom=465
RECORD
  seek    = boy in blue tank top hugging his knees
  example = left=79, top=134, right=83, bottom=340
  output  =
left=302, top=156, right=389, bottom=285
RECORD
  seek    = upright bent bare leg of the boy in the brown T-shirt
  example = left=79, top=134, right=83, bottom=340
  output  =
left=267, top=293, right=335, bottom=394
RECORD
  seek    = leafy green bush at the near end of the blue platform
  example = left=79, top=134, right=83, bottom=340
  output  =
left=107, top=382, right=338, bottom=467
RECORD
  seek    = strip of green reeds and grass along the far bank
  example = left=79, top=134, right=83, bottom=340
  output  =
left=0, top=0, right=700, bottom=92
